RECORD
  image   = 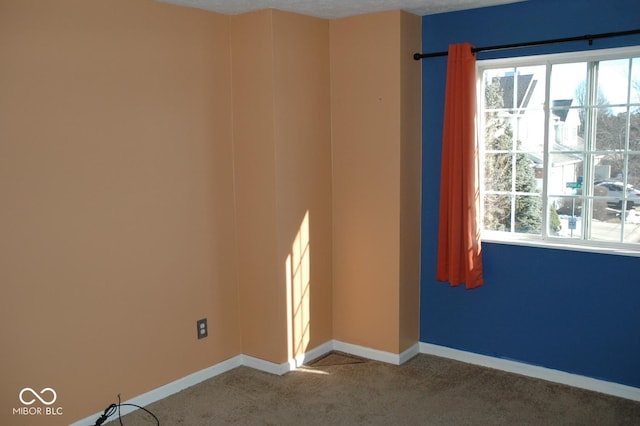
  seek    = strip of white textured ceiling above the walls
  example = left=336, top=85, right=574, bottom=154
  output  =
left=157, top=0, right=524, bottom=19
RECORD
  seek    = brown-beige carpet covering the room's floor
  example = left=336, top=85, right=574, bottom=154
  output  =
left=110, top=352, right=640, bottom=426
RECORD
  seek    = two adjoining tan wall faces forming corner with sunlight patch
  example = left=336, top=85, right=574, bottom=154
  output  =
left=231, top=10, right=332, bottom=363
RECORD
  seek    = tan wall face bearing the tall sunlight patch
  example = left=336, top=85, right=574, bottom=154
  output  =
left=273, top=11, right=333, bottom=358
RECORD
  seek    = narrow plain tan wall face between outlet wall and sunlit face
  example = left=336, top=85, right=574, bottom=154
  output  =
left=231, top=13, right=286, bottom=362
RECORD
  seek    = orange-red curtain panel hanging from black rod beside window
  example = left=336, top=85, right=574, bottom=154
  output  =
left=436, top=43, right=483, bottom=288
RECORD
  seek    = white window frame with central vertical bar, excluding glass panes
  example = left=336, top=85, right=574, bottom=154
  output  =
left=476, top=46, right=640, bottom=257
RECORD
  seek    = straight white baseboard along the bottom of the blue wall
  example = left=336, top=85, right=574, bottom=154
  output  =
left=419, top=342, right=640, bottom=401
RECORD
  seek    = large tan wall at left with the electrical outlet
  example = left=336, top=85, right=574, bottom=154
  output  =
left=0, top=0, right=240, bottom=425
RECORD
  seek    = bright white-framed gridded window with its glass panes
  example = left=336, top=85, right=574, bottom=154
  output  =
left=478, top=48, right=640, bottom=253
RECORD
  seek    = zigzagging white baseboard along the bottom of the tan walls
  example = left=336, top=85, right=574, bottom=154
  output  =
left=71, top=340, right=420, bottom=426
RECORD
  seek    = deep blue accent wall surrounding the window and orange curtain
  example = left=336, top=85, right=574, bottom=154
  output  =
left=420, top=0, right=640, bottom=388
